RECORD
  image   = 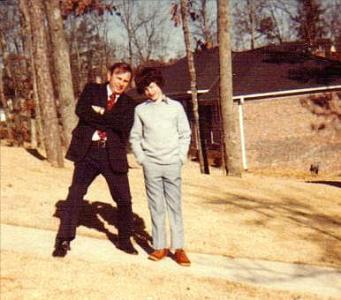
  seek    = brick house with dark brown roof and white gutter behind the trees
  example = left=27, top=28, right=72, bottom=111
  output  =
left=130, top=44, right=341, bottom=173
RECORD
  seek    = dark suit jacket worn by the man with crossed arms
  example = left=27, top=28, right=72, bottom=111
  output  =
left=66, top=83, right=135, bottom=172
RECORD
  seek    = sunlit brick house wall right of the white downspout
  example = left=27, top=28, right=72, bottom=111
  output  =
left=239, top=95, right=341, bottom=173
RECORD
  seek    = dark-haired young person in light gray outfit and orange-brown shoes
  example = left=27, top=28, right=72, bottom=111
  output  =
left=130, top=68, right=191, bottom=266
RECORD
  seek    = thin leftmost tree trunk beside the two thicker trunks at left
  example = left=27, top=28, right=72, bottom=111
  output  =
left=20, top=0, right=45, bottom=150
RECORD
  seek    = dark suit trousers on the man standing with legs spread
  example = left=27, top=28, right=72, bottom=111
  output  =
left=57, top=143, right=132, bottom=241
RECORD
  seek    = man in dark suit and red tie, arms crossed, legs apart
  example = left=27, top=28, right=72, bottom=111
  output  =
left=52, top=63, right=138, bottom=257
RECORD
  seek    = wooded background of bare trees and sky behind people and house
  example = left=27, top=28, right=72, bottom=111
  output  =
left=0, top=0, right=341, bottom=174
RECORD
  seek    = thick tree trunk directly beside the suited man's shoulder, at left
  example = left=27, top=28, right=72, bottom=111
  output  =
left=45, top=0, right=77, bottom=147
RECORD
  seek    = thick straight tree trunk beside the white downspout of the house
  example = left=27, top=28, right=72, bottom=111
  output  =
left=218, top=0, right=241, bottom=176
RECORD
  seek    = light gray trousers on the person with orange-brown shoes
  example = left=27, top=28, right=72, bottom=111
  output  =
left=143, top=162, right=184, bottom=250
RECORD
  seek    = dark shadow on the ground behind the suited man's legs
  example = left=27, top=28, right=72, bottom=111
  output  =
left=53, top=200, right=153, bottom=254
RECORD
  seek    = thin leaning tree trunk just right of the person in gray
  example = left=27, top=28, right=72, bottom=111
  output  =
left=181, top=0, right=209, bottom=174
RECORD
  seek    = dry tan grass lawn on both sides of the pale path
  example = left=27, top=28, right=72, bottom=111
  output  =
left=0, top=146, right=341, bottom=299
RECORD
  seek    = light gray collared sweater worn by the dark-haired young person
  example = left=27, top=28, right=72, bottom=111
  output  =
left=129, top=97, right=191, bottom=165
